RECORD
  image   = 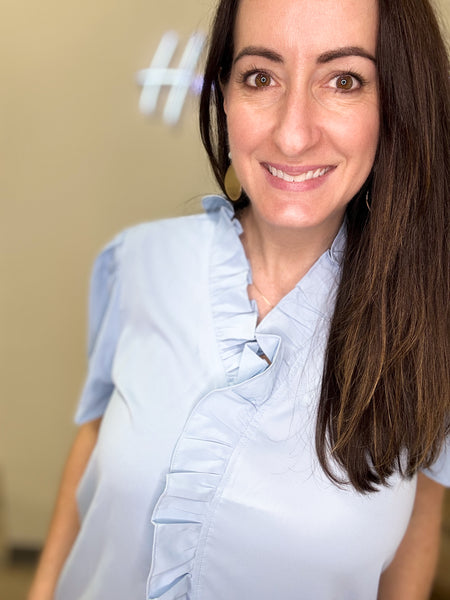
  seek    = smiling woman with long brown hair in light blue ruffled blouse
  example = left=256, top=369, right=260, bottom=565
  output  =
left=30, top=0, right=450, bottom=600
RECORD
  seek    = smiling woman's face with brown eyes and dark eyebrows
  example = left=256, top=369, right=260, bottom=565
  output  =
left=223, top=0, right=379, bottom=235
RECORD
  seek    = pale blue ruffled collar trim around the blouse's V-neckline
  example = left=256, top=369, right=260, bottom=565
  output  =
left=203, top=196, right=347, bottom=385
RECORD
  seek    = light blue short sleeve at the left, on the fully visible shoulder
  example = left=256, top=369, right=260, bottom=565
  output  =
left=75, top=233, right=124, bottom=424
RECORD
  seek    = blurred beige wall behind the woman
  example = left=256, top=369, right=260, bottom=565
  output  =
left=0, top=0, right=450, bottom=600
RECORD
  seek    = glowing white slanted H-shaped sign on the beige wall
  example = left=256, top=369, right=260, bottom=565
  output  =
left=137, top=31, right=206, bottom=125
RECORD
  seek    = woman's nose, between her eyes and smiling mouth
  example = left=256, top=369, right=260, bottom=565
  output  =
left=273, top=88, right=321, bottom=158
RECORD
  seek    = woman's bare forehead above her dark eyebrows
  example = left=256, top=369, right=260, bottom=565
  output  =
left=234, top=0, right=378, bottom=56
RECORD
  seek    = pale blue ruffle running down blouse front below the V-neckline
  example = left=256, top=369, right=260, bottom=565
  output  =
left=147, top=335, right=281, bottom=600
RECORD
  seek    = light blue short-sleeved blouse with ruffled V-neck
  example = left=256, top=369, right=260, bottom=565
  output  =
left=56, top=196, right=450, bottom=600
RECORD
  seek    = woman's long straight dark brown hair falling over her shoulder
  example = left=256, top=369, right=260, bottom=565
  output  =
left=200, top=0, right=450, bottom=492
